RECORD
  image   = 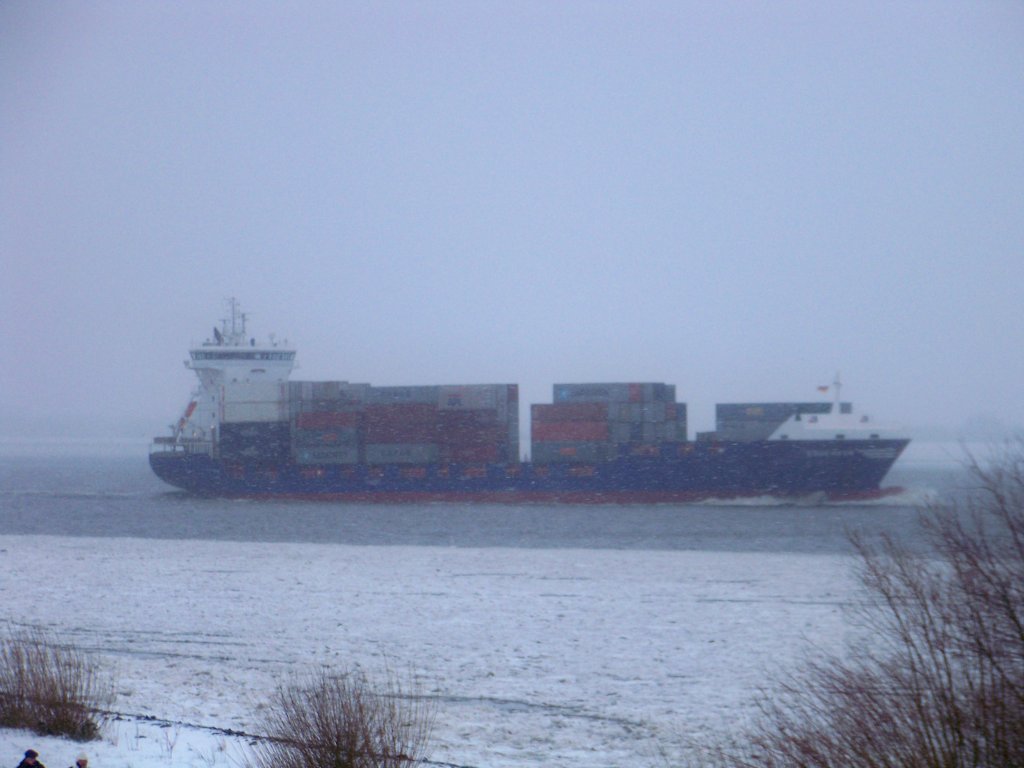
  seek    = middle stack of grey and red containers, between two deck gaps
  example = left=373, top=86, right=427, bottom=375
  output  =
left=530, top=383, right=686, bottom=464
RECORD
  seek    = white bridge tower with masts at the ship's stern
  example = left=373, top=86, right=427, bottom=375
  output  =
left=167, top=299, right=295, bottom=441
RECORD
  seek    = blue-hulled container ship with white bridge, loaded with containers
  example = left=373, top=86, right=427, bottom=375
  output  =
left=150, top=299, right=909, bottom=504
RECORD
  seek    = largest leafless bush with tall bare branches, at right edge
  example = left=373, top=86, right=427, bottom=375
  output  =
left=679, top=442, right=1024, bottom=768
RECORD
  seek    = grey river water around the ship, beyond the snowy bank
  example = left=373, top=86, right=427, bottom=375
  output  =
left=0, top=444, right=966, bottom=553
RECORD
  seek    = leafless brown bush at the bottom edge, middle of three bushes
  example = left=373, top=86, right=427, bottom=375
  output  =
left=248, top=670, right=434, bottom=768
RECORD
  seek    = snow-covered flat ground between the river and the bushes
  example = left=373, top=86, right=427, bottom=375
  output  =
left=0, top=536, right=856, bottom=768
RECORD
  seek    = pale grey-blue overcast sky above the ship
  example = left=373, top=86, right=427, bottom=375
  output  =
left=0, top=0, right=1024, bottom=436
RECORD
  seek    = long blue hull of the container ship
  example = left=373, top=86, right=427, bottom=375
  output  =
left=150, top=439, right=909, bottom=504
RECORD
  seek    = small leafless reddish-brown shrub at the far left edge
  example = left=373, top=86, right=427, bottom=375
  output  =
left=0, top=629, right=114, bottom=740
